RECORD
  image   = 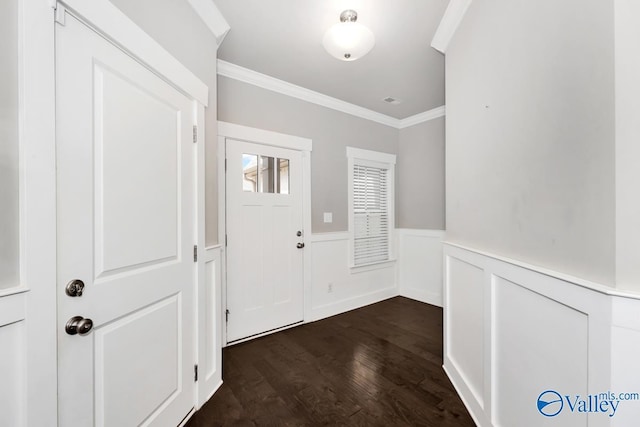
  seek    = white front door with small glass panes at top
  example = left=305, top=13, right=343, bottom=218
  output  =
left=226, top=139, right=304, bottom=342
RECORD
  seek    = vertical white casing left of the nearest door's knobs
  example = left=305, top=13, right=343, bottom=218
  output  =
left=18, top=1, right=58, bottom=427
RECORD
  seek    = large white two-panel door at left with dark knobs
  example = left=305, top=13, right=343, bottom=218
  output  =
left=56, top=15, right=195, bottom=426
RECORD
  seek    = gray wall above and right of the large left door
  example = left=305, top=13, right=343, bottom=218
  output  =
left=111, top=0, right=218, bottom=245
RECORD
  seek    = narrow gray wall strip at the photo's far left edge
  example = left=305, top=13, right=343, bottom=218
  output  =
left=0, top=0, right=20, bottom=289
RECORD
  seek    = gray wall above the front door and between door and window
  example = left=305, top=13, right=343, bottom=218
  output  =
left=218, top=76, right=398, bottom=233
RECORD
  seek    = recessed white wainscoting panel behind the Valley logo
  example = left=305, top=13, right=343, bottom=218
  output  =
left=492, top=277, right=588, bottom=427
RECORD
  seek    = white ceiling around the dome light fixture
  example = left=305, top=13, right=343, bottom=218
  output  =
left=214, top=0, right=449, bottom=119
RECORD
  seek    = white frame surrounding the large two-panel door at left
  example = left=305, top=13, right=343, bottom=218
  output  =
left=18, top=0, right=209, bottom=427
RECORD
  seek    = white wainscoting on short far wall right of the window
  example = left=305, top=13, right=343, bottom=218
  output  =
left=396, top=228, right=444, bottom=307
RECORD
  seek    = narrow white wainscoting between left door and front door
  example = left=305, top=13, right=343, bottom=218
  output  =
left=197, top=246, right=223, bottom=408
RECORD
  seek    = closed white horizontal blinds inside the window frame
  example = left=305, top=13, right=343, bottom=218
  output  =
left=353, top=164, right=390, bottom=266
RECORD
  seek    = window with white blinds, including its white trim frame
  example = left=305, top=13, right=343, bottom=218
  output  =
left=347, top=147, right=395, bottom=267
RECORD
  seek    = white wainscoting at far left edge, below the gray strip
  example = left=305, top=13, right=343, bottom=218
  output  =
left=0, top=293, right=27, bottom=426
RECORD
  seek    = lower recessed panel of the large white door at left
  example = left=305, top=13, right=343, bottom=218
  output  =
left=94, top=295, right=180, bottom=426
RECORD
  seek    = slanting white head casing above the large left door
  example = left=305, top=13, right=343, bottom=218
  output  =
left=59, top=0, right=209, bottom=107
